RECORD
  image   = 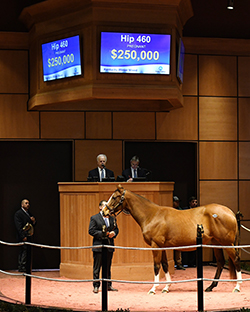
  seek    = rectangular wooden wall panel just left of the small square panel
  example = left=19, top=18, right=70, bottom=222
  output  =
left=41, top=112, right=84, bottom=139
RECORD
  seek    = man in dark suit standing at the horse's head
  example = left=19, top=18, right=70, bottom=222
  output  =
left=89, top=200, right=119, bottom=294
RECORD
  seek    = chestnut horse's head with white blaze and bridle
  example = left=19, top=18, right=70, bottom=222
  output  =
left=103, top=184, right=126, bottom=215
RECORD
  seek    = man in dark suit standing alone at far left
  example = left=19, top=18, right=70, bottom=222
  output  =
left=14, top=199, right=36, bottom=272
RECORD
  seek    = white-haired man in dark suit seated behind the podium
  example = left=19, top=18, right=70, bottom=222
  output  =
left=88, top=154, right=115, bottom=182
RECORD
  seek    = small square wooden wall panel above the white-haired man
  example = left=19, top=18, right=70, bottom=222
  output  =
left=86, top=112, right=112, bottom=139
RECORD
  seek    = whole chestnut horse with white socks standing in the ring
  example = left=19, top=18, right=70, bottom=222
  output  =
left=103, top=185, right=241, bottom=294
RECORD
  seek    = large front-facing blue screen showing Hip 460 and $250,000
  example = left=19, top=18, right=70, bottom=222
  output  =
left=100, top=32, right=171, bottom=75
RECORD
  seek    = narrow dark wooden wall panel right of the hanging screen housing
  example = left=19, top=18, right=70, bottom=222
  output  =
left=182, top=54, right=198, bottom=95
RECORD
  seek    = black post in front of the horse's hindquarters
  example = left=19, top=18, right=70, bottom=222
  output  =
left=196, top=224, right=204, bottom=312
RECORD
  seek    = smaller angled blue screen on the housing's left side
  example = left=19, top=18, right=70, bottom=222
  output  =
left=42, top=36, right=82, bottom=81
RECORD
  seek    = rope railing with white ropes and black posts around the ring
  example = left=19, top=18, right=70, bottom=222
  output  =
left=0, top=225, right=250, bottom=311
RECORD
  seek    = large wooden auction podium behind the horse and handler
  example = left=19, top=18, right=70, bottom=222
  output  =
left=58, top=182, right=174, bottom=280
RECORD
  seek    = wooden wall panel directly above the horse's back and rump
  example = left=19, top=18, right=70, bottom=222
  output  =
left=200, top=181, right=238, bottom=213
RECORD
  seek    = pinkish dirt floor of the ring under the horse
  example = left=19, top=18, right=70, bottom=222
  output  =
left=0, top=266, right=250, bottom=312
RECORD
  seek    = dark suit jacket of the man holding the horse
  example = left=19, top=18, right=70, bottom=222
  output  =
left=89, top=213, right=119, bottom=252
